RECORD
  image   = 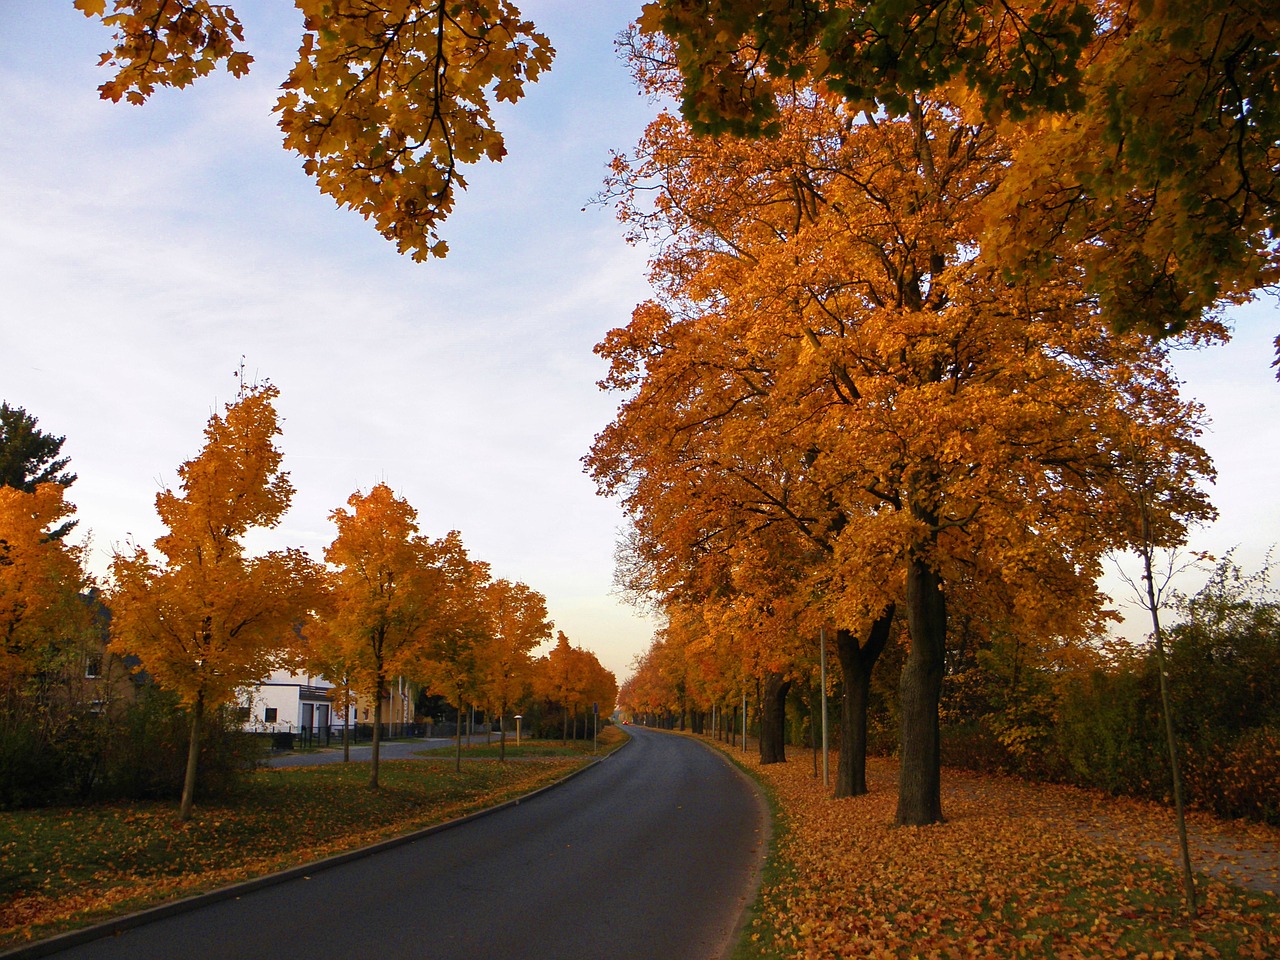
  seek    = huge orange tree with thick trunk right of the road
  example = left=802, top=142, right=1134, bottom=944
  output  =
left=589, top=75, right=1208, bottom=823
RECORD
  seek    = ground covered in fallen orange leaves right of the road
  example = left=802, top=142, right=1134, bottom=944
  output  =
left=733, top=751, right=1280, bottom=960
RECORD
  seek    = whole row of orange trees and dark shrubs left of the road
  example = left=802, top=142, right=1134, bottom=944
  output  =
left=0, top=383, right=617, bottom=819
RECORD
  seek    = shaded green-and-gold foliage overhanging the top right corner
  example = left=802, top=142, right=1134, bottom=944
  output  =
left=640, top=0, right=1280, bottom=353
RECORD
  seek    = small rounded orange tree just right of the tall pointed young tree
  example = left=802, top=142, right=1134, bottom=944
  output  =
left=324, top=484, right=461, bottom=790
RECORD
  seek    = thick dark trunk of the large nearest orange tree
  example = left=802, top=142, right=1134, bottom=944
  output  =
left=895, top=552, right=947, bottom=826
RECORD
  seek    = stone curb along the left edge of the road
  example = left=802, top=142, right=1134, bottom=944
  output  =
left=0, top=737, right=631, bottom=960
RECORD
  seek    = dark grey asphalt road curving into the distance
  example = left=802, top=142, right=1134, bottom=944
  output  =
left=47, top=728, right=767, bottom=960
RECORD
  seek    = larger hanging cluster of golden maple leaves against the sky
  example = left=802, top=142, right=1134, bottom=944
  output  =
left=276, top=0, right=554, bottom=261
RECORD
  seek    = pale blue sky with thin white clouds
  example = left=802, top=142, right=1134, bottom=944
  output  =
left=0, top=0, right=1280, bottom=680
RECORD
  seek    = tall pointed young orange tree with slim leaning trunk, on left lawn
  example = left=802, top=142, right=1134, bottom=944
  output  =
left=110, top=384, right=316, bottom=820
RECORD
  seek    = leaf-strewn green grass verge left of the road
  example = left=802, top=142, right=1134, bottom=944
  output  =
left=0, top=752, right=601, bottom=948
